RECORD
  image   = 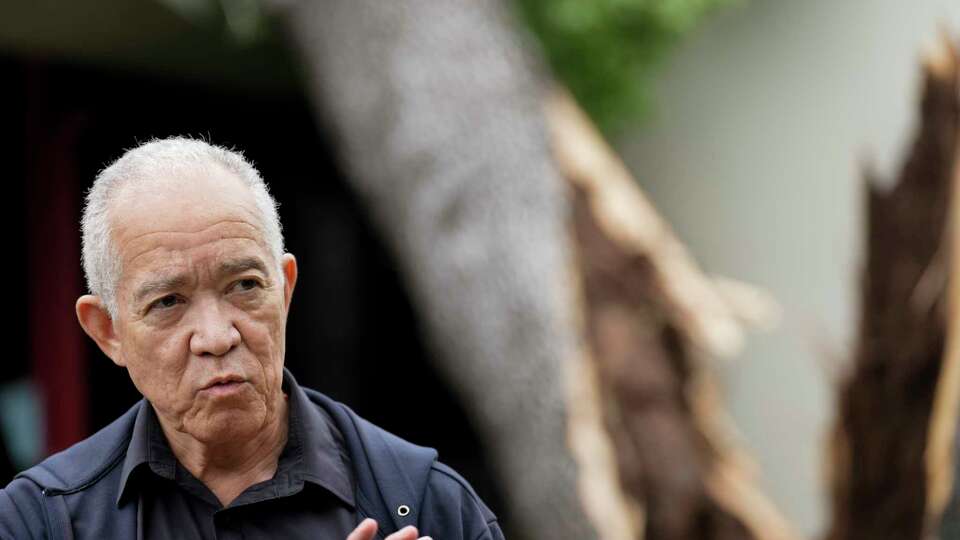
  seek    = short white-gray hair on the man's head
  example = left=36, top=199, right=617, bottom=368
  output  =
left=81, top=137, right=283, bottom=318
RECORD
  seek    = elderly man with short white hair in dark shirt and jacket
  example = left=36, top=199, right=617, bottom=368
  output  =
left=0, top=138, right=503, bottom=540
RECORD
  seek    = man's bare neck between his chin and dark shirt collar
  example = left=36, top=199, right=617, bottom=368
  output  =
left=160, top=395, right=289, bottom=506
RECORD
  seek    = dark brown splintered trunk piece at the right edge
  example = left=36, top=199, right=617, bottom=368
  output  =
left=828, top=39, right=960, bottom=540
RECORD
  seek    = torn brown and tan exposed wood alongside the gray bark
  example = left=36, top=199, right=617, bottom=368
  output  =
left=548, top=89, right=796, bottom=540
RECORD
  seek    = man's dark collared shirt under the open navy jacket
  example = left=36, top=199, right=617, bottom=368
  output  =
left=117, top=370, right=357, bottom=540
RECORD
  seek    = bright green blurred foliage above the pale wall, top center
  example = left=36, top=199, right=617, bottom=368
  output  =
left=517, top=0, right=736, bottom=133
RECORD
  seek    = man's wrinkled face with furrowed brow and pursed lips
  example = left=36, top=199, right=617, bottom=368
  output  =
left=105, top=166, right=296, bottom=444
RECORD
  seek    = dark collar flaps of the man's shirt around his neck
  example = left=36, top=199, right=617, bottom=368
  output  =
left=117, top=368, right=356, bottom=507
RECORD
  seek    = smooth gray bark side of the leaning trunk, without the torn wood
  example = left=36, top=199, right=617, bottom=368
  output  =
left=279, top=0, right=596, bottom=540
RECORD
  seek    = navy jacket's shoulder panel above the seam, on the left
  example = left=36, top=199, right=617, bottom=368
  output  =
left=17, top=401, right=143, bottom=493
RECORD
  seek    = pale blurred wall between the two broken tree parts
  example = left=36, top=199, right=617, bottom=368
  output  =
left=618, top=0, right=960, bottom=535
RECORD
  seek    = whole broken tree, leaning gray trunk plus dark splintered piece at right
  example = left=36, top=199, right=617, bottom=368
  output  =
left=276, top=0, right=960, bottom=540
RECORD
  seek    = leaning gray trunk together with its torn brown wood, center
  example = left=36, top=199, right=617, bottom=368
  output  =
left=274, top=0, right=792, bottom=540
